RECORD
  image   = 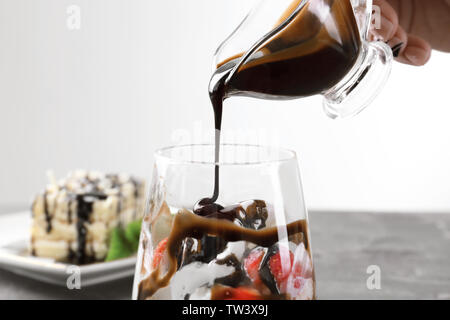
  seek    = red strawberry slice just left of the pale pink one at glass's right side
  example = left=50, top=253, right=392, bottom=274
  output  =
left=269, top=246, right=294, bottom=293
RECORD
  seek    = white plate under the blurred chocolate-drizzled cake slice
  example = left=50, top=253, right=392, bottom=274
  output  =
left=0, top=212, right=136, bottom=287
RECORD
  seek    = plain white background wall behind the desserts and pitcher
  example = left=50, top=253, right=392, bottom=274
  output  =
left=0, top=0, right=450, bottom=212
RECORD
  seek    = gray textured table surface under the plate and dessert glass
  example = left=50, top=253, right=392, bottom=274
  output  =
left=0, top=207, right=450, bottom=299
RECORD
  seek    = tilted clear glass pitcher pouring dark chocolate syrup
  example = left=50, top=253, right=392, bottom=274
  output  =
left=213, top=0, right=393, bottom=118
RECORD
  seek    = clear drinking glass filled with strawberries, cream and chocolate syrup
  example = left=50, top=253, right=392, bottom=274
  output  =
left=133, top=144, right=316, bottom=300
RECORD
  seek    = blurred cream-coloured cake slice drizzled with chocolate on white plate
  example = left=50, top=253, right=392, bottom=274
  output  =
left=31, top=171, right=145, bottom=264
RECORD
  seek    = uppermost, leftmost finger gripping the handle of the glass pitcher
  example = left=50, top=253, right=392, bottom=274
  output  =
left=371, top=0, right=399, bottom=41
